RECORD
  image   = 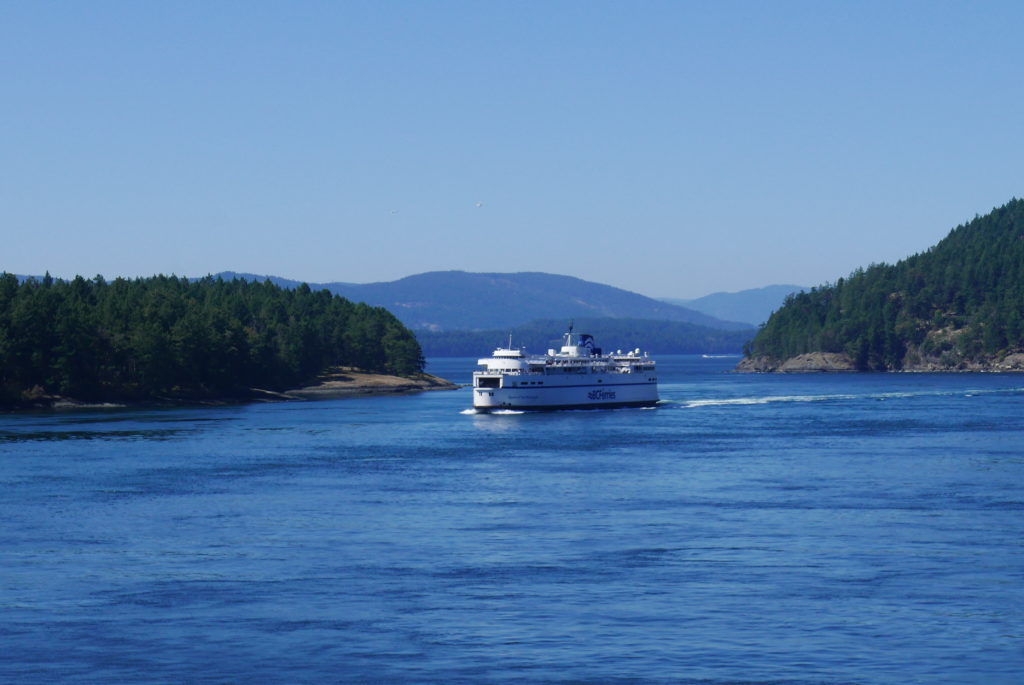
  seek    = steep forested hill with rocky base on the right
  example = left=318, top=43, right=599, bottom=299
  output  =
left=738, top=199, right=1024, bottom=371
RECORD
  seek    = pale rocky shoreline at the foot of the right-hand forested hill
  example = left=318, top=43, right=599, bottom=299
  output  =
left=734, top=352, right=1024, bottom=374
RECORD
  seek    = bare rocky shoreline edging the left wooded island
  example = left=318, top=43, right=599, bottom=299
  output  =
left=0, top=367, right=461, bottom=411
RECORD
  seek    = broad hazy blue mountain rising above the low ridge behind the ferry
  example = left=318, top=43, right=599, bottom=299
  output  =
left=215, top=271, right=751, bottom=331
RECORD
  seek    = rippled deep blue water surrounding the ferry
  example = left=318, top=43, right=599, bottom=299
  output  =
left=0, top=356, right=1024, bottom=684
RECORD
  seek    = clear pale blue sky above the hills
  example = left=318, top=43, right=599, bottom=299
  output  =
left=0, top=0, right=1024, bottom=297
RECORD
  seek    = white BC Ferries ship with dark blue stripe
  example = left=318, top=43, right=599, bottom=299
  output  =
left=473, top=326, right=657, bottom=412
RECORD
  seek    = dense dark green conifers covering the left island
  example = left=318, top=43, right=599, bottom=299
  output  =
left=0, top=273, right=423, bottom=403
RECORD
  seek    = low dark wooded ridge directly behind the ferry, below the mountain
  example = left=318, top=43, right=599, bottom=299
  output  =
left=416, top=318, right=754, bottom=357
